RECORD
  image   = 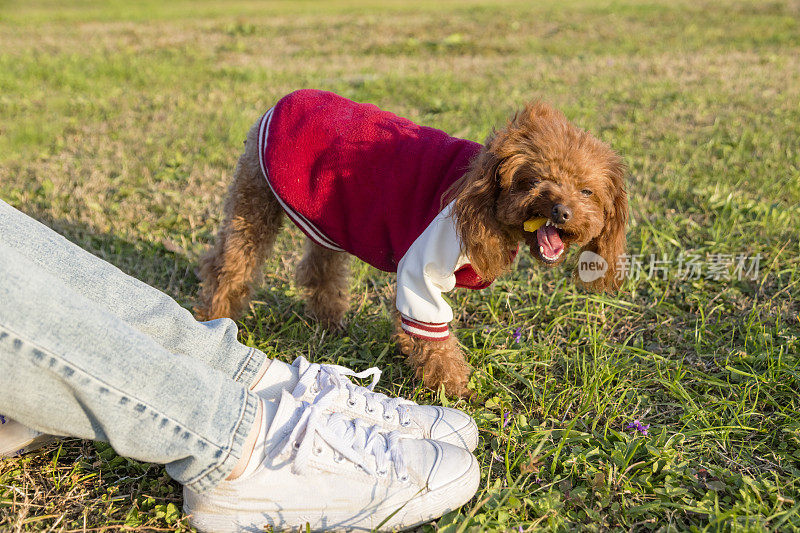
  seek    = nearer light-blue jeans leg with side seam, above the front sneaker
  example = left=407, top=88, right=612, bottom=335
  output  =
left=0, top=243, right=258, bottom=492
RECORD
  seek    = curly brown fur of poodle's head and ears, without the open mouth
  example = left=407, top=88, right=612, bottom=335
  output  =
left=454, top=102, right=628, bottom=290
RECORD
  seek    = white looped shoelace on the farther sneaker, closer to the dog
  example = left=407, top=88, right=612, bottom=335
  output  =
left=292, top=356, right=416, bottom=427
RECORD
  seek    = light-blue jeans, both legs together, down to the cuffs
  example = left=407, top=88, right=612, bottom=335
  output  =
left=0, top=201, right=266, bottom=492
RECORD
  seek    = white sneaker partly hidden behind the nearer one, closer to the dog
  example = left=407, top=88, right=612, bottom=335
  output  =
left=256, top=356, right=478, bottom=451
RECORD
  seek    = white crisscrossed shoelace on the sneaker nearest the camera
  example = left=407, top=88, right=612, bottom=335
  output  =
left=269, top=390, right=408, bottom=481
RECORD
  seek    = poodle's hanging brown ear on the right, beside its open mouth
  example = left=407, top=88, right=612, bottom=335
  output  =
left=576, top=157, right=628, bottom=291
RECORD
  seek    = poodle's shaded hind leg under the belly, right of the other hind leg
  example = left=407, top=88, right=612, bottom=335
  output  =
left=295, top=239, right=350, bottom=329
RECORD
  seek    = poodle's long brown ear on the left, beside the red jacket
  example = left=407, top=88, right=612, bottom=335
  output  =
left=454, top=133, right=509, bottom=280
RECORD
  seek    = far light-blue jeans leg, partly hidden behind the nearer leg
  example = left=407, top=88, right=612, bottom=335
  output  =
left=0, top=200, right=266, bottom=384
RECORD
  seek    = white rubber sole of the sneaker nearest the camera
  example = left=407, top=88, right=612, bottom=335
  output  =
left=184, top=450, right=480, bottom=533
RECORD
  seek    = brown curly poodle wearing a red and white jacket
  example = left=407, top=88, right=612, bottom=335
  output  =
left=196, top=91, right=628, bottom=395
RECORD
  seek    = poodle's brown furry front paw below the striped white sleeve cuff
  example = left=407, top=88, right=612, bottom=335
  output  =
left=394, top=313, right=470, bottom=396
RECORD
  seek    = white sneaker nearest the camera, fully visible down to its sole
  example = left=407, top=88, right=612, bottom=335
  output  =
left=183, top=391, right=480, bottom=533
